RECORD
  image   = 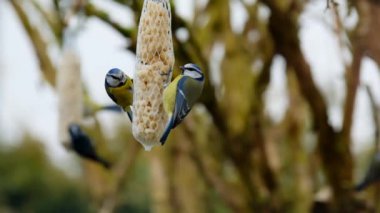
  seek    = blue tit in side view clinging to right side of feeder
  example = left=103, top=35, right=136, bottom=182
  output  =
left=160, top=64, right=205, bottom=145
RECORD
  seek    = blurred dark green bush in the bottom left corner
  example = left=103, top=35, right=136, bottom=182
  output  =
left=0, top=138, right=91, bottom=212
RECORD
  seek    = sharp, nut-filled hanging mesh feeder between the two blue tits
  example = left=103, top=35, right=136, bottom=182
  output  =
left=132, top=0, right=174, bottom=151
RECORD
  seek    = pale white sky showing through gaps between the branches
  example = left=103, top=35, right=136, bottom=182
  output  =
left=0, top=0, right=380, bottom=171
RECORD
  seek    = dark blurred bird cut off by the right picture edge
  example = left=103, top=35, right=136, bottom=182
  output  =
left=355, top=152, right=380, bottom=191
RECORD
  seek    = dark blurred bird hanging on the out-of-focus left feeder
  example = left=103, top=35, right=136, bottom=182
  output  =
left=68, top=123, right=111, bottom=169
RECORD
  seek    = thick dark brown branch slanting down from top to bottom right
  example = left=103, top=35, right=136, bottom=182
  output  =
left=262, top=0, right=353, bottom=211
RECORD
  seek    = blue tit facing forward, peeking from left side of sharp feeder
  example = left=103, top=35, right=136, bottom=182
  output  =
left=104, top=68, right=133, bottom=122
